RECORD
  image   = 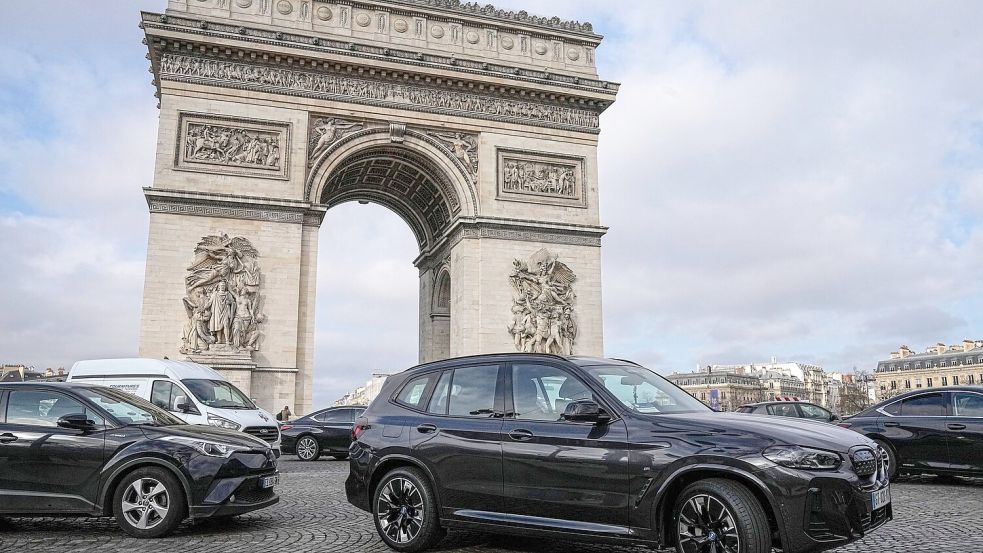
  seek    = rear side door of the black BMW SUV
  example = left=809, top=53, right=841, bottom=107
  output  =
left=408, top=364, right=504, bottom=519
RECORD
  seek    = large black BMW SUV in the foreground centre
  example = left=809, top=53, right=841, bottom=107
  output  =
left=345, top=354, right=892, bottom=553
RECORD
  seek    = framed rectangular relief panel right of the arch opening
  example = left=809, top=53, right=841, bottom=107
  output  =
left=497, top=148, right=587, bottom=207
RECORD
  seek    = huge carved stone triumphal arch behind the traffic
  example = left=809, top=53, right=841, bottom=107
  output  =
left=140, top=0, right=618, bottom=412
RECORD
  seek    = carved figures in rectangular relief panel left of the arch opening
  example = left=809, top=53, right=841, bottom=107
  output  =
left=184, top=124, right=280, bottom=168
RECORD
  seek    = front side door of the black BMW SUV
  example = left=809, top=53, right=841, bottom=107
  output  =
left=502, top=363, right=629, bottom=534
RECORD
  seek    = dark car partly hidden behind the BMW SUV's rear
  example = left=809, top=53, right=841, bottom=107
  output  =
left=280, top=405, right=365, bottom=461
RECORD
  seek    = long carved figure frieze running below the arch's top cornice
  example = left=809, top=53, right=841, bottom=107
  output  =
left=160, top=53, right=599, bottom=132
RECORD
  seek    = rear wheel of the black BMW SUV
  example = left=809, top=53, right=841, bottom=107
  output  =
left=372, top=467, right=445, bottom=553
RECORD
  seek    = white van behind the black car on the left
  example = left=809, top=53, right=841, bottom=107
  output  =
left=66, top=358, right=280, bottom=457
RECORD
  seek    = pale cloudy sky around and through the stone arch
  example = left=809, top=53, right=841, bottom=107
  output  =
left=0, top=0, right=983, bottom=404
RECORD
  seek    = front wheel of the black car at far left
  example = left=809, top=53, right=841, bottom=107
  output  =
left=113, top=467, right=188, bottom=538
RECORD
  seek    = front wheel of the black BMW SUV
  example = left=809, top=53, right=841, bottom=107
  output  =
left=672, top=478, right=771, bottom=553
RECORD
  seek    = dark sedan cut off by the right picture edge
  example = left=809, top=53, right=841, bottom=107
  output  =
left=840, top=386, right=983, bottom=477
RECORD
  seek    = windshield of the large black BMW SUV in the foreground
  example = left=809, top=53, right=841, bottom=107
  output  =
left=584, top=365, right=710, bottom=414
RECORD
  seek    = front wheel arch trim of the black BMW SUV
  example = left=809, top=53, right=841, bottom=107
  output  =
left=653, top=465, right=788, bottom=547
